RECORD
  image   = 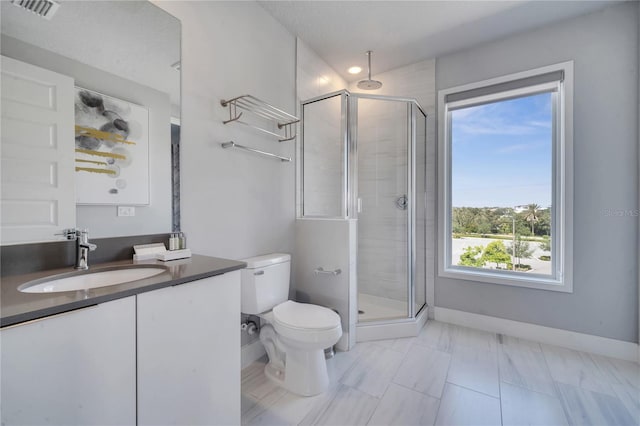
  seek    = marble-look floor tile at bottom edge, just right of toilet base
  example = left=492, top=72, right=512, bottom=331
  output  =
left=314, top=385, right=378, bottom=426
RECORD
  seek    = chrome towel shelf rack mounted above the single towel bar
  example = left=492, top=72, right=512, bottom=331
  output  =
left=220, top=95, right=300, bottom=142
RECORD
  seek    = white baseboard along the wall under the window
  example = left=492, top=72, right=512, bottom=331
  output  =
left=434, top=307, right=640, bottom=362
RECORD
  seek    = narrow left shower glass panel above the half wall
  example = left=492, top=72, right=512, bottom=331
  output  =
left=301, top=94, right=347, bottom=217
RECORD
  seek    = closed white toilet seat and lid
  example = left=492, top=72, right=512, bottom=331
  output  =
left=272, top=300, right=342, bottom=345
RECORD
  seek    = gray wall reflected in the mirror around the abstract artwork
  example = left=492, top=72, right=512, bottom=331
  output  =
left=2, top=36, right=171, bottom=238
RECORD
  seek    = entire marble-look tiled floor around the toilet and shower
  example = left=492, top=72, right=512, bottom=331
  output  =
left=241, top=321, right=640, bottom=426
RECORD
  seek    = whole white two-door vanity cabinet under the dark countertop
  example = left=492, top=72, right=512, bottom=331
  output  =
left=0, top=271, right=240, bottom=425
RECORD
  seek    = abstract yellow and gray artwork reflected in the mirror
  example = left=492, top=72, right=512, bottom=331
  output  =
left=75, top=87, right=149, bottom=205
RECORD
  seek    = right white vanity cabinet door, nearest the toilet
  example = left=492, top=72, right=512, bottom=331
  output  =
left=137, top=271, right=240, bottom=425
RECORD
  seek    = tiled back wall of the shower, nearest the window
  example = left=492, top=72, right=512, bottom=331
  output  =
left=349, top=60, right=436, bottom=305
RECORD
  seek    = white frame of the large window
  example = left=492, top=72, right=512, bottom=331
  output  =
left=437, top=61, right=573, bottom=293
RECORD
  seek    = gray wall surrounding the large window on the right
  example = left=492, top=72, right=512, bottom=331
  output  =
left=435, top=2, right=638, bottom=342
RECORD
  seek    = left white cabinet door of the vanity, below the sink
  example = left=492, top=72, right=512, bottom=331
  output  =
left=0, top=296, right=136, bottom=425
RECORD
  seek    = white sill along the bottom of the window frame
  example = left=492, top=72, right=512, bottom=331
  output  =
left=438, top=266, right=573, bottom=293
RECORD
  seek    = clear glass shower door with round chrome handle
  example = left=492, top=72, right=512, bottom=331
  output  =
left=351, top=97, right=411, bottom=322
